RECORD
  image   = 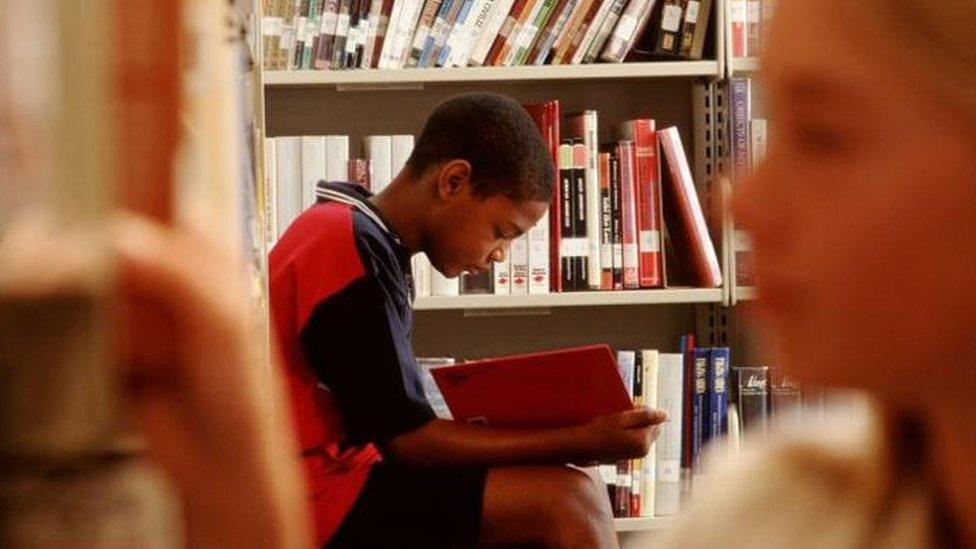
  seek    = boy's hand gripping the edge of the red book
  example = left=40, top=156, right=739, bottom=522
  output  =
left=578, top=407, right=668, bottom=463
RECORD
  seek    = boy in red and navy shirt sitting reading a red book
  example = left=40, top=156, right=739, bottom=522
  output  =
left=270, top=94, right=663, bottom=548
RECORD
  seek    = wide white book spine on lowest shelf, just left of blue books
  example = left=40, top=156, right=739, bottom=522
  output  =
left=654, top=353, right=684, bottom=517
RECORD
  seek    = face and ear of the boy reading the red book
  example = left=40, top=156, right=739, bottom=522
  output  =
left=424, top=161, right=549, bottom=278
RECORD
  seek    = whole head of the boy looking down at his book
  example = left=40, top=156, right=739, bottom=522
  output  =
left=407, top=93, right=555, bottom=277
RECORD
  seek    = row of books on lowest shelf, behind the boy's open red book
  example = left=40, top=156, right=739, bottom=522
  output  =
left=418, top=336, right=823, bottom=517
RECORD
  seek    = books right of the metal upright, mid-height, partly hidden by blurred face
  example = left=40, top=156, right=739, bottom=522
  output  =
left=727, top=78, right=769, bottom=286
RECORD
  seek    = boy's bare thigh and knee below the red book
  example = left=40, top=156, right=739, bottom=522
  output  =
left=481, top=466, right=612, bottom=546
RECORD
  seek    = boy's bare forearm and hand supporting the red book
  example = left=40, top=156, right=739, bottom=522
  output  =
left=384, top=408, right=666, bottom=466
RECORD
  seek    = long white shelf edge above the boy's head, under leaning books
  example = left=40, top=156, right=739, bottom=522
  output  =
left=264, top=61, right=719, bottom=88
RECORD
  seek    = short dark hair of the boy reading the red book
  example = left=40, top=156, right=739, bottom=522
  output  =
left=407, top=93, right=555, bottom=202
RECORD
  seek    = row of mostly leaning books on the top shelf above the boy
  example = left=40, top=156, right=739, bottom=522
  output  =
left=262, top=0, right=713, bottom=70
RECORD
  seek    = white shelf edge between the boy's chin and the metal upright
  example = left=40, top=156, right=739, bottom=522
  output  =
left=414, top=288, right=722, bottom=311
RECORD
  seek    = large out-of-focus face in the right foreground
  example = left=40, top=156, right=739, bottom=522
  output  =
left=736, top=0, right=976, bottom=400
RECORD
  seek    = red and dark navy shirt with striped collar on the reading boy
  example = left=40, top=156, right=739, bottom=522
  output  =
left=269, top=182, right=434, bottom=545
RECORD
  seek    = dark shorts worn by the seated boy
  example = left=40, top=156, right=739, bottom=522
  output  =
left=326, top=462, right=488, bottom=549
